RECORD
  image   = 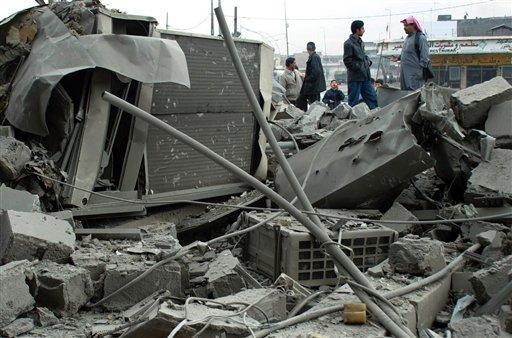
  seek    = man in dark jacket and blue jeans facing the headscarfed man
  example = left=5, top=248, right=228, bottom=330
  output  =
left=343, top=20, right=377, bottom=109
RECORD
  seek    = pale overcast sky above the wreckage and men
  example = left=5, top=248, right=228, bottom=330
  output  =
left=0, top=0, right=512, bottom=55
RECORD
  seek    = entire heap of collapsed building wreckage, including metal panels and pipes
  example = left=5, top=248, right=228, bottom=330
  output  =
left=0, top=1, right=512, bottom=337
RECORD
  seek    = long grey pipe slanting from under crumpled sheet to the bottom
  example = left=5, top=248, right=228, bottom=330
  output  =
left=102, top=92, right=409, bottom=337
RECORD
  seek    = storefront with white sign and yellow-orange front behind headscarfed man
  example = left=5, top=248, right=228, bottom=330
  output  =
left=379, top=36, right=512, bottom=88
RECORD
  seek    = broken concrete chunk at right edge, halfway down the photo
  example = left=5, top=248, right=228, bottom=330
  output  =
left=466, top=149, right=512, bottom=198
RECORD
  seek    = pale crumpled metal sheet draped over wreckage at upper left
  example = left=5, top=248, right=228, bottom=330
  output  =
left=5, top=8, right=190, bottom=136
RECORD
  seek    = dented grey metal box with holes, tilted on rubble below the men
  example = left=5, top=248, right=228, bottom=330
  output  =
left=275, top=92, right=434, bottom=209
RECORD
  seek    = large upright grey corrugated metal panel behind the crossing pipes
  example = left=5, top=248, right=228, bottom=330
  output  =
left=147, top=34, right=260, bottom=193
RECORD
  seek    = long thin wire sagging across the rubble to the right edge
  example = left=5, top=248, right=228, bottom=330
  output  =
left=32, top=172, right=512, bottom=225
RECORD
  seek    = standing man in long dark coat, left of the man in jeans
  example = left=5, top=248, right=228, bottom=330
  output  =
left=297, top=42, right=325, bottom=111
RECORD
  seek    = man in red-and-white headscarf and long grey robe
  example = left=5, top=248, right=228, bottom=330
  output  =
left=391, top=16, right=433, bottom=90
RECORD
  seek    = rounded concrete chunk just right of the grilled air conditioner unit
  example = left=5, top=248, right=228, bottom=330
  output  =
left=389, top=235, right=446, bottom=276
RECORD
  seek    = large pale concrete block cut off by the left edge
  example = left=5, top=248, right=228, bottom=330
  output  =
left=0, top=210, right=75, bottom=262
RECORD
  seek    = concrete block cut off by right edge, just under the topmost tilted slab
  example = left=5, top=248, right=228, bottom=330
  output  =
left=485, top=100, right=512, bottom=146
